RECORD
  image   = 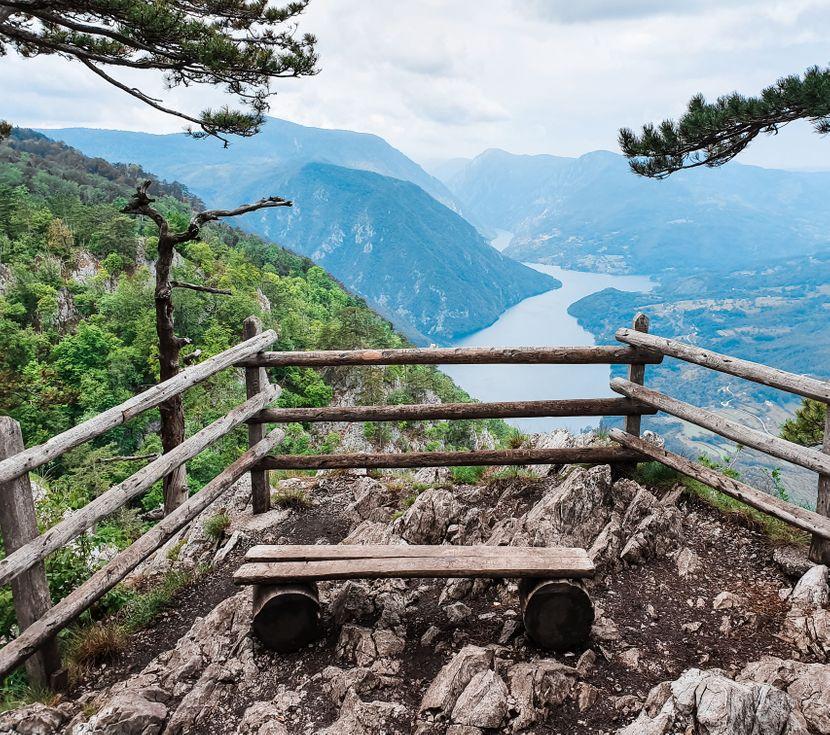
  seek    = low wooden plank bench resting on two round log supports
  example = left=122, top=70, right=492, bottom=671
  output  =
left=234, top=545, right=594, bottom=652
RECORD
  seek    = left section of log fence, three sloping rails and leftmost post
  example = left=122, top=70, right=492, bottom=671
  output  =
left=0, top=324, right=284, bottom=688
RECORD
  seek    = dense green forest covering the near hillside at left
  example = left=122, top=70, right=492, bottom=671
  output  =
left=0, top=130, right=506, bottom=664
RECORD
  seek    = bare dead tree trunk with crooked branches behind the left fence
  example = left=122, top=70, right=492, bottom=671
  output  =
left=123, top=181, right=291, bottom=514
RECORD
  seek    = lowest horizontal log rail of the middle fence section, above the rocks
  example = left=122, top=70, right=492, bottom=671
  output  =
left=258, top=446, right=642, bottom=470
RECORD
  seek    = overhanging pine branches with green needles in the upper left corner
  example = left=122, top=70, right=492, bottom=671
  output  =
left=0, top=0, right=317, bottom=145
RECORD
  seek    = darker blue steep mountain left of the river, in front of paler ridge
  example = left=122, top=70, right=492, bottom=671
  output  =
left=232, top=163, right=560, bottom=342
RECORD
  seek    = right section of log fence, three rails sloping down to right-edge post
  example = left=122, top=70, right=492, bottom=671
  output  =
left=611, top=329, right=830, bottom=564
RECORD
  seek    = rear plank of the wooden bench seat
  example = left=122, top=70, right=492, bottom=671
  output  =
left=245, top=544, right=600, bottom=564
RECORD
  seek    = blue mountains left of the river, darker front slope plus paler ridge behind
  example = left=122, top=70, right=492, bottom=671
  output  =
left=43, top=118, right=559, bottom=342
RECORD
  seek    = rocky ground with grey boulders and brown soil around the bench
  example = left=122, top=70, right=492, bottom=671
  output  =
left=6, top=432, right=830, bottom=735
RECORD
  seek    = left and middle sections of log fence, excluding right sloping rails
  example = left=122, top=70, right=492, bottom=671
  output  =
left=0, top=317, right=662, bottom=685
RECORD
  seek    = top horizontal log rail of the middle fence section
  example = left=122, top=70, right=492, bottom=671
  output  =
left=238, top=345, right=663, bottom=367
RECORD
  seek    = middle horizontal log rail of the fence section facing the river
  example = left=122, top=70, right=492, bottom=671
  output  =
left=248, top=396, right=657, bottom=423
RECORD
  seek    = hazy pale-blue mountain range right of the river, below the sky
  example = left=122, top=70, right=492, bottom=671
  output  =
left=447, top=150, right=830, bottom=273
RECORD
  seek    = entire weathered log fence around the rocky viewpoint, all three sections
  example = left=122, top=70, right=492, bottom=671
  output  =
left=0, top=315, right=830, bottom=685
